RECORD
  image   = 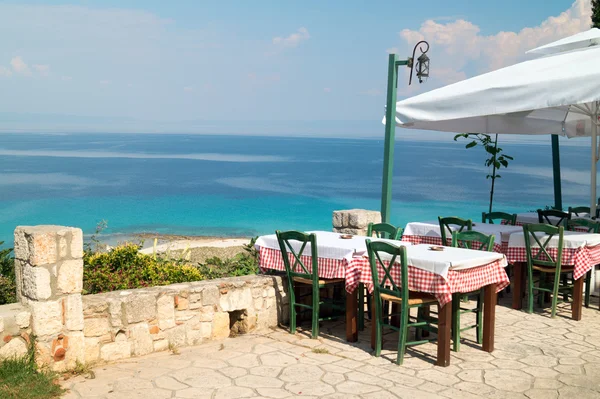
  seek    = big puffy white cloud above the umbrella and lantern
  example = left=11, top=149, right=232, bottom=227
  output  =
left=396, top=0, right=591, bottom=89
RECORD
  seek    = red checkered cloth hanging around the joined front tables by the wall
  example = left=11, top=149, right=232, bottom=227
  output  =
left=259, top=247, right=510, bottom=306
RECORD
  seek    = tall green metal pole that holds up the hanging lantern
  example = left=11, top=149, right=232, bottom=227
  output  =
left=381, top=54, right=408, bottom=223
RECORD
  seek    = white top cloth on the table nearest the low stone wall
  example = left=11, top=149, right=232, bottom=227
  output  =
left=254, top=231, right=412, bottom=261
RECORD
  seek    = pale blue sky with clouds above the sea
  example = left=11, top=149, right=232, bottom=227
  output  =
left=0, top=0, right=590, bottom=136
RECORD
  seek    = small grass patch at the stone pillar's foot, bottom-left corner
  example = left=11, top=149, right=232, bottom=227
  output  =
left=0, top=340, right=64, bottom=399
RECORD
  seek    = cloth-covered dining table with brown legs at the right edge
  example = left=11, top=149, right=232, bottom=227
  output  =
left=506, top=231, right=600, bottom=320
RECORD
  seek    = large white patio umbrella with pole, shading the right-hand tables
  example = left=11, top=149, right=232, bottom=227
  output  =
left=396, top=35, right=600, bottom=214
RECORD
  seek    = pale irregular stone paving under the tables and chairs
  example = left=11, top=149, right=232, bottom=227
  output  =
left=62, top=298, right=600, bottom=399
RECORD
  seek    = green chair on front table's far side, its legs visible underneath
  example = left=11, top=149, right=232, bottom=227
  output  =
left=452, top=231, right=495, bottom=352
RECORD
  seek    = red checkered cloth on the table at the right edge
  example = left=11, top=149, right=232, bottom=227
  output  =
left=506, top=246, right=600, bottom=280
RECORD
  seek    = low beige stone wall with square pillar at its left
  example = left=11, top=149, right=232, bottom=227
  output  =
left=11, top=226, right=288, bottom=371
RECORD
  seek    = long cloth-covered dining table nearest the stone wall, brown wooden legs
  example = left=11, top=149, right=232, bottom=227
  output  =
left=255, top=231, right=510, bottom=367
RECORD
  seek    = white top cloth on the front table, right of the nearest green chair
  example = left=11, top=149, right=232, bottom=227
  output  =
left=406, top=244, right=508, bottom=278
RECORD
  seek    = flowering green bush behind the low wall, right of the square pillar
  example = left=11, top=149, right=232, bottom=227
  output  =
left=83, top=244, right=204, bottom=294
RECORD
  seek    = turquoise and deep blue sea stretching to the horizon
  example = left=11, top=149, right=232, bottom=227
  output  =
left=0, top=133, right=590, bottom=245
